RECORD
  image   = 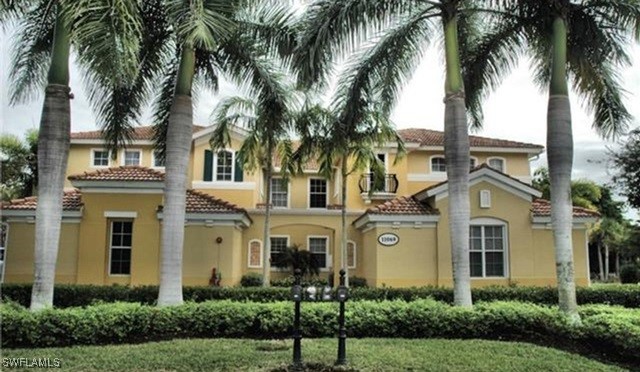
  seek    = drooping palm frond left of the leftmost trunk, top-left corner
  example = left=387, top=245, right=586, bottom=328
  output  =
left=9, top=1, right=57, bottom=104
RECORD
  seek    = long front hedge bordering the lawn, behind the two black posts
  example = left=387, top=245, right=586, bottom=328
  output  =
left=0, top=300, right=640, bottom=365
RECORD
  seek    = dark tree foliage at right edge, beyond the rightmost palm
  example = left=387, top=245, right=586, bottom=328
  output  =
left=610, top=129, right=640, bottom=208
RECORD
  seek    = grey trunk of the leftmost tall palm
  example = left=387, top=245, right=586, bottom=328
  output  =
left=30, top=12, right=71, bottom=310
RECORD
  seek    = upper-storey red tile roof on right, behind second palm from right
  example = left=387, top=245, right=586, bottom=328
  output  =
left=398, top=128, right=544, bottom=150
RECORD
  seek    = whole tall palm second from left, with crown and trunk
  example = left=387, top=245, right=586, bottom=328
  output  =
left=125, top=0, right=295, bottom=306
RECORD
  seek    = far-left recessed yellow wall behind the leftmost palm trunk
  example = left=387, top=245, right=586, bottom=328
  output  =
left=4, top=222, right=80, bottom=283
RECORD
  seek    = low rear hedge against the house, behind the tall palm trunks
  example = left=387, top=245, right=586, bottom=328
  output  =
left=2, top=284, right=640, bottom=308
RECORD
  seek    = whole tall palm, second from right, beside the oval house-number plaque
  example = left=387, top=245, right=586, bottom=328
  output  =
left=294, top=0, right=496, bottom=306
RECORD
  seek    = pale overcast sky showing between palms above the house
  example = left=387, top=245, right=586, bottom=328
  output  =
left=0, top=29, right=640, bottom=219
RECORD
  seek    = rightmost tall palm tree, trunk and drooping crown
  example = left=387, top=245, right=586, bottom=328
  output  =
left=465, top=0, right=640, bottom=321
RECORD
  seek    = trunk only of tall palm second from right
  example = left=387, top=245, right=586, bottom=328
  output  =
left=444, top=17, right=473, bottom=307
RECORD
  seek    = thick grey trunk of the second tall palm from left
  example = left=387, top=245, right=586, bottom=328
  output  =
left=158, top=46, right=195, bottom=306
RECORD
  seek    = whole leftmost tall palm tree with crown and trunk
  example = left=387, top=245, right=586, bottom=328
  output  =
left=0, top=0, right=140, bottom=310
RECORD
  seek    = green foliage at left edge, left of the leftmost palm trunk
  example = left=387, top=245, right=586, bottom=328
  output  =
left=0, top=129, right=38, bottom=200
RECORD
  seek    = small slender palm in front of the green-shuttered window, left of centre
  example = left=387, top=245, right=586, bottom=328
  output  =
left=210, top=77, right=296, bottom=287
